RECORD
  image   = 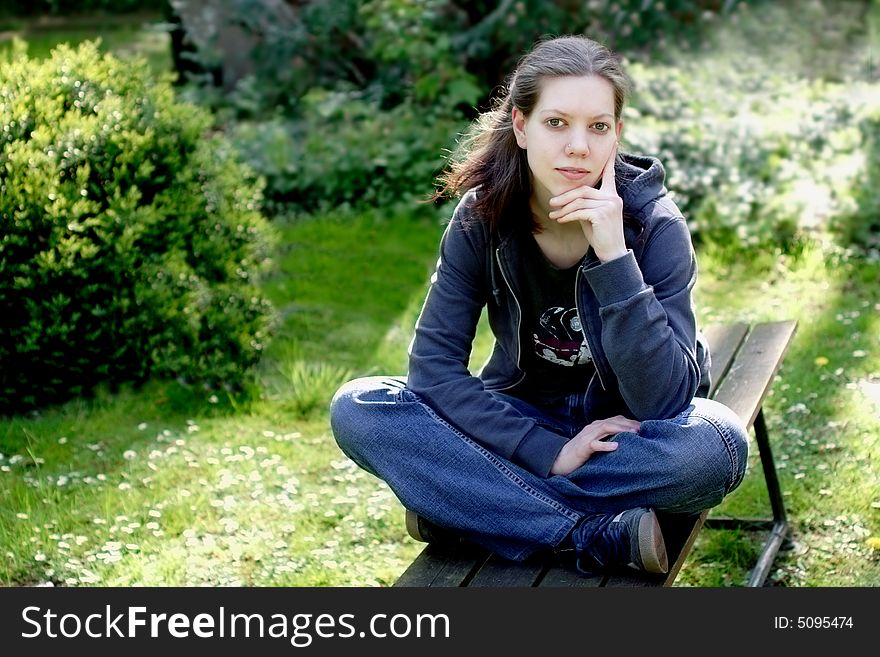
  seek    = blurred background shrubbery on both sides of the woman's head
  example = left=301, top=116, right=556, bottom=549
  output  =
left=171, top=0, right=880, bottom=250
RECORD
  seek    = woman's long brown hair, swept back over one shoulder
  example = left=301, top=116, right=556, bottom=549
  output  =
left=436, top=36, right=632, bottom=231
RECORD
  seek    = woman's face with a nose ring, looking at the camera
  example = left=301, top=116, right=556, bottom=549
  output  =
left=512, top=75, right=623, bottom=218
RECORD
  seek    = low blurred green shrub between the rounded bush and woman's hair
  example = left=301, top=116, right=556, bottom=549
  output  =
left=230, top=92, right=466, bottom=211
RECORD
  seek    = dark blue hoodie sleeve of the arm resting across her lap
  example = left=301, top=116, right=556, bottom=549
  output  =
left=407, top=206, right=566, bottom=476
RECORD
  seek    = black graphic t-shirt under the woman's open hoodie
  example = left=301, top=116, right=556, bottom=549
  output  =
left=520, top=238, right=595, bottom=400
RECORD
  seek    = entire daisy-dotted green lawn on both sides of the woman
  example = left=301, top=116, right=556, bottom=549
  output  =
left=0, top=205, right=880, bottom=586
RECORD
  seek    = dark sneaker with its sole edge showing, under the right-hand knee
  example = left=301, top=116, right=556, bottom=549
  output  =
left=572, top=509, right=669, bottom=574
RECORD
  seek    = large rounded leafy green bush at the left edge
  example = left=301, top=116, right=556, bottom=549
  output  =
left=0, top=43, right=272, bottom=412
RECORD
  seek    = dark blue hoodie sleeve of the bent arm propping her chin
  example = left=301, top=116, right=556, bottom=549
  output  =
left=585, top=211, right=700, bottom=420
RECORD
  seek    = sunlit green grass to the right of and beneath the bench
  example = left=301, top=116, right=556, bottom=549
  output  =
left=679, top=244, right=880, bottom=586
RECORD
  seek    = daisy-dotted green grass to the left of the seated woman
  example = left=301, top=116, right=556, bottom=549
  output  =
left=0, top=204, right=440, bottom=586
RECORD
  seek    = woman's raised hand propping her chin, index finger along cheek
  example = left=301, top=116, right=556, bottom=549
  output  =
left=549, top=144, right=626, bottom=262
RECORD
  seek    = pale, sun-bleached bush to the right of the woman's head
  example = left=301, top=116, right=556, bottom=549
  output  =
left=624, top=53, right=878, bottom=250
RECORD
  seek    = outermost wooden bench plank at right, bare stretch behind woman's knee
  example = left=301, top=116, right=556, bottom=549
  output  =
left=713, top=321, right=797, bottom=427
